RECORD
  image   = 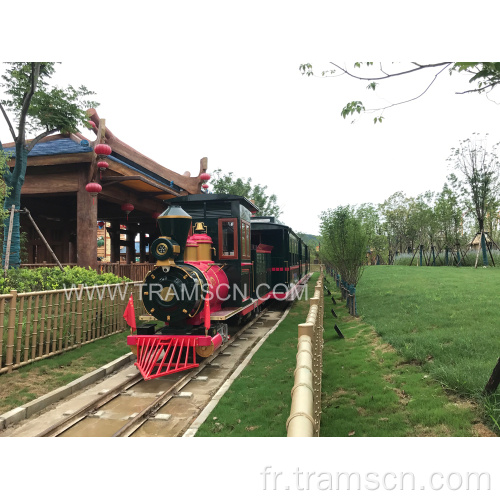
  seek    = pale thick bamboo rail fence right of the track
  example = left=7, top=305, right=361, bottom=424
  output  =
left=286, top=271, right=324, bottom=437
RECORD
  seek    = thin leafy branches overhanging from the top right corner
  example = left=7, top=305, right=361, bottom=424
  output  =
left=299, top=62, right=500, bottom=123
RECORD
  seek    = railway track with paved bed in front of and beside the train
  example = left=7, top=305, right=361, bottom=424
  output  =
left=5, top=302, right=288, bottom=437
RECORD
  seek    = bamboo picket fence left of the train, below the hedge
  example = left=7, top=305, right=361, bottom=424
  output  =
left=0, top=282, right=143, bottom=374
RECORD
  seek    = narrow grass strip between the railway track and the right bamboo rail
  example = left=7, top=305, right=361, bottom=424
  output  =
left=196, top=273, right=318, bottom=437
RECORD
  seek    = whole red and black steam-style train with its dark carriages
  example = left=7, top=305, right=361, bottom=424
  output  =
left=127, top=193, right=309, bottom=380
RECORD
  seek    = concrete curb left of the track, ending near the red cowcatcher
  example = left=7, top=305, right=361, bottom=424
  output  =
left=0, top=352, right=135, bottom=430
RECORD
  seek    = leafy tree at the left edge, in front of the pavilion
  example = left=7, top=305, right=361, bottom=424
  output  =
left=0, top=62, right=97, bottom=267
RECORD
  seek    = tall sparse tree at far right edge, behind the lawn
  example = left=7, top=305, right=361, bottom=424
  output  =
left=448, top=134, right=500, bottom=266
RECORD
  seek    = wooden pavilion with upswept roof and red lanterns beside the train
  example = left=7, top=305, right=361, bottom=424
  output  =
left=4, top=109, right=207, bottom=268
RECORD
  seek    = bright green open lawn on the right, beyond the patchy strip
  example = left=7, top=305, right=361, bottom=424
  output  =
left=357, top=266, right=500, bottom=432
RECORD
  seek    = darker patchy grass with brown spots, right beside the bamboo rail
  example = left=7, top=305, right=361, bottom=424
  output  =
left=320, top=279, right=492, bottom=437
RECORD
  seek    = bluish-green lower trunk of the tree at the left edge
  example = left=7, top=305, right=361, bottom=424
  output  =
left=2, top=144, right=28, bottom=267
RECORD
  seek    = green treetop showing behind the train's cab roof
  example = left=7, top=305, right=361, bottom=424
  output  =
left=212, top=169, right=282, bottom=218
